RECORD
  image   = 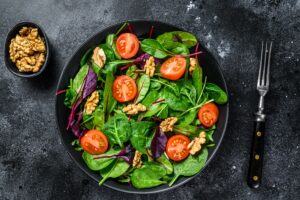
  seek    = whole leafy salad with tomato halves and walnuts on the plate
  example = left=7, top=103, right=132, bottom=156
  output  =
left=58, top=23, right=228, bottom=189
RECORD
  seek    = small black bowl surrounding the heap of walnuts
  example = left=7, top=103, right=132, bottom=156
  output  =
left=4, top=22, right=50, bottom=78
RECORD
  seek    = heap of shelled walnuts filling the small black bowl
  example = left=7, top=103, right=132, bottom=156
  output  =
left=9, top=27, right=46, bottom=72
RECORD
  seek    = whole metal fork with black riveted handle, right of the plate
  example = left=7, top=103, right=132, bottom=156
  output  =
left=247, top=42, right=273, bottom=188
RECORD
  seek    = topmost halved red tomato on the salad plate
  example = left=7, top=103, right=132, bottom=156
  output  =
left=116, top=33, right=140, bottom=59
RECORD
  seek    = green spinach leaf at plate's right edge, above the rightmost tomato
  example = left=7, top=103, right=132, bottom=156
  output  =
left=205, top=83, right=228, bottom=104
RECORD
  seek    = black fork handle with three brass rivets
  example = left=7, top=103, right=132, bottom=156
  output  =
left=247, top=121, right=265, bottom=188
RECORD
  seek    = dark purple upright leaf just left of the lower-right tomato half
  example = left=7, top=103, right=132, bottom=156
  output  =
left=151, top=126, right=168, bottom=159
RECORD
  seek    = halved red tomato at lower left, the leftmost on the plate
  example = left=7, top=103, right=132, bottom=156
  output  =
left=80, top=130, right=108, bottom=155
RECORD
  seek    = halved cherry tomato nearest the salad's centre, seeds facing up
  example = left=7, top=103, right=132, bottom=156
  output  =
left=112, top=75, right=137, bottom=102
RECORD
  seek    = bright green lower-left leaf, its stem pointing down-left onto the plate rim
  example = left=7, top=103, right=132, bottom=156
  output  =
left=99, top=158, right=130, bottom=185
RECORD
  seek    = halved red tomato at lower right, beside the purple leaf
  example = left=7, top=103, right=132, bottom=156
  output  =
left=166, top=135, right=190, bottom=161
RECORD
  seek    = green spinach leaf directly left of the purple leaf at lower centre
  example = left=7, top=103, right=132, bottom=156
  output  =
left=130, top=121, right=155, bottom=154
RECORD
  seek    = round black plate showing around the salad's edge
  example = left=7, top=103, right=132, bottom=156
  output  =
left=56, top=21, right=229, bottom=194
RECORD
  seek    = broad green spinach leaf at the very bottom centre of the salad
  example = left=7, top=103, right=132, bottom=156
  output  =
left=130, top=163, right=167, bottom=189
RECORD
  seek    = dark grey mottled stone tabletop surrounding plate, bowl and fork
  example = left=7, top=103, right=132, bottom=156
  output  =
left=0, top=0, right=300, bottom=200
